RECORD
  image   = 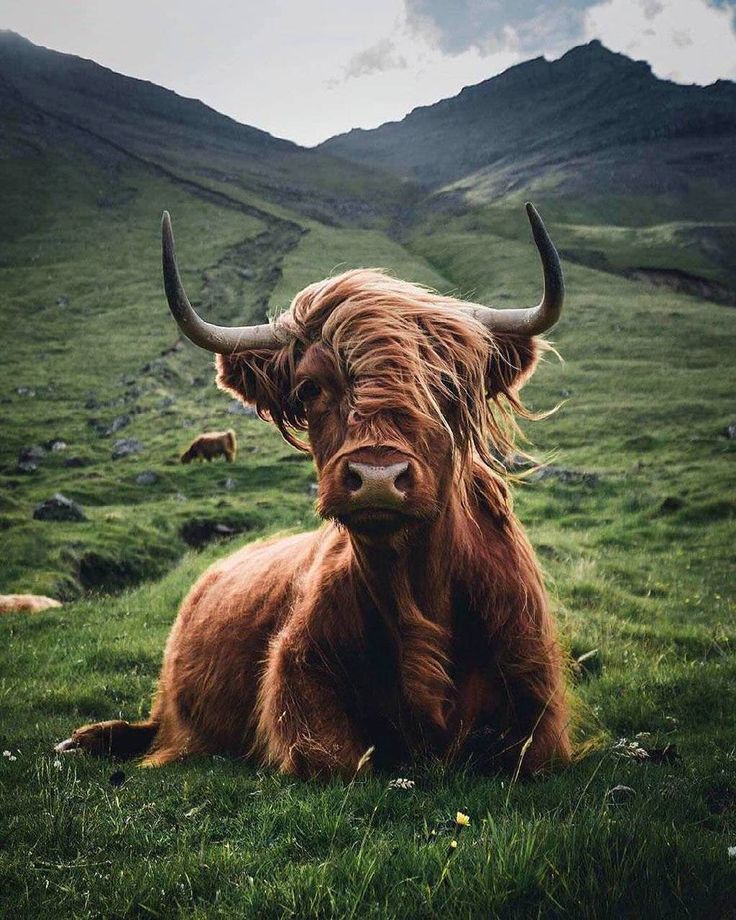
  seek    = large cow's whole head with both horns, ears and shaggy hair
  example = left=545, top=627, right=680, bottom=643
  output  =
left=163, top=205, right=563, bottom=539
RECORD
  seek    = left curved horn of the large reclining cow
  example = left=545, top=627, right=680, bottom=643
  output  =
left=161, top=211, right=291, bottom=355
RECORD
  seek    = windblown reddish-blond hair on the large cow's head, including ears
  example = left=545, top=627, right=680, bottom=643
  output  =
left=218, top=269, right=545, bottom=488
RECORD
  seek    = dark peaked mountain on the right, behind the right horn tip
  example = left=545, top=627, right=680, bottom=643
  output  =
left=319, top=41, right=736, bottom=303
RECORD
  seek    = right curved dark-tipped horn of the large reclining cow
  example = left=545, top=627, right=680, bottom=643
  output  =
left=462, top=202, right=565, bottom=335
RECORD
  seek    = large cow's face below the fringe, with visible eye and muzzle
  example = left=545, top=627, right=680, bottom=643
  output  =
left=294, top=345, right=453, bottom=537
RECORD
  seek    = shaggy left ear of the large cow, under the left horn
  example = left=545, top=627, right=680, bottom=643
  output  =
left=217, top=349, right=292, bottom=430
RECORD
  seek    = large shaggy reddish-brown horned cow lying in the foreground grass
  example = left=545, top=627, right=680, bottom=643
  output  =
left=60, top=206, right=570, bottom=777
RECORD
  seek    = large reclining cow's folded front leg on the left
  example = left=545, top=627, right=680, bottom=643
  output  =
left=258, top=633, right=369, bottom=778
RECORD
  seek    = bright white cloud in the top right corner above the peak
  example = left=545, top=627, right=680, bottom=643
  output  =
left=585, top=0, right=736, bottom=84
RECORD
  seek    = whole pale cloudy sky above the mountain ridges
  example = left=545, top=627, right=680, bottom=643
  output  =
left=0, top=0, right=736, bottom=145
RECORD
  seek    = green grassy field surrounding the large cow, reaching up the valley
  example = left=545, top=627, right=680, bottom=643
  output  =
left=0, top=140, right=736, bottom=918
